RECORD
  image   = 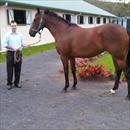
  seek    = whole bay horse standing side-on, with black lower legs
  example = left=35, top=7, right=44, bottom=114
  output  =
left=29, top=9, right=130, bottom=100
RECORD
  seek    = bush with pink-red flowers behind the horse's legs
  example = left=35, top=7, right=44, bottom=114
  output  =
left=76, top=58, right=113, bottom=80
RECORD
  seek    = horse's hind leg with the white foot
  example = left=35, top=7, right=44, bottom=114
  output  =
left=110, top=58, right=122, bottom=93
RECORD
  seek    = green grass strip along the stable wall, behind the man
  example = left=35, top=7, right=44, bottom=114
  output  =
left=0, top=43, right=55, bottom=63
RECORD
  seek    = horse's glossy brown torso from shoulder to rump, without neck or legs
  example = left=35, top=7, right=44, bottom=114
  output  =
left=56, top=24, right=128, bottom=57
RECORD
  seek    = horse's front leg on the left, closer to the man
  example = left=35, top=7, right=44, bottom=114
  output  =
left=61, top=56, right=69, bottom=92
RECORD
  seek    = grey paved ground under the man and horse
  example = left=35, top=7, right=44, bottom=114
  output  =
left=0, top=50, right=130, bottom=130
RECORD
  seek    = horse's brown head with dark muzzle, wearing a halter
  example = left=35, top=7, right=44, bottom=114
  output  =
left=29, top=9, right=44, bottom=37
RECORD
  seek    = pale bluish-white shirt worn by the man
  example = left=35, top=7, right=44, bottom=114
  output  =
left=2, top=31, right=23, bottom=51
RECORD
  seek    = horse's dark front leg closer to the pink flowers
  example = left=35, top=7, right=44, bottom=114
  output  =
left=70, top=58, right=77, bottom=89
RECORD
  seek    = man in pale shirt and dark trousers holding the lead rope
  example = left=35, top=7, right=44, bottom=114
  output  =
left=2, top=20, right=23, bottom=90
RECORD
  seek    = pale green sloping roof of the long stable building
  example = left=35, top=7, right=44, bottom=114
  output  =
left=0, top=0, right=116, bottom=17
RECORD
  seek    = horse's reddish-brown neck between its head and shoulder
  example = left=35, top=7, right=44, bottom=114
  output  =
left=46, top=19, right=68, bottom=40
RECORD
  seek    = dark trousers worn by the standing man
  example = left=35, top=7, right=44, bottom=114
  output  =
left=7, top=51, right=22, bottom=85
